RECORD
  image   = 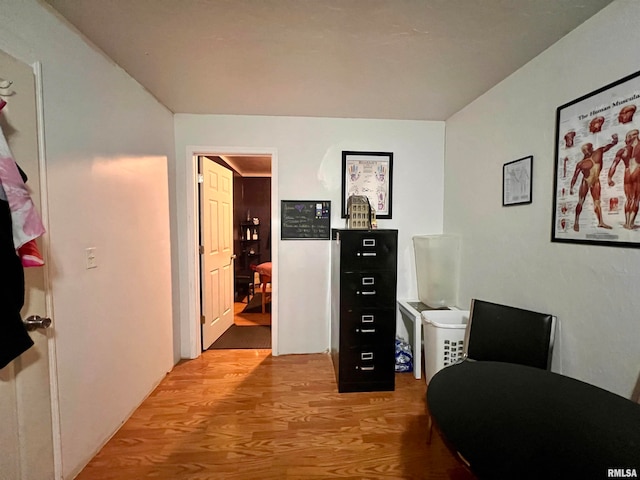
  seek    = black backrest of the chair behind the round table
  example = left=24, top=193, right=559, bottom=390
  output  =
left=463, top=299, right=556, bottom=370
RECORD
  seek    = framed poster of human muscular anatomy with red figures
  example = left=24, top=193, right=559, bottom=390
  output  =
left=551, top=68, right=640, bottom=248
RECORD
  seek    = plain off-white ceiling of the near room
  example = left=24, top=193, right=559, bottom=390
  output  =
left=41, top=0, right=612, bottom=175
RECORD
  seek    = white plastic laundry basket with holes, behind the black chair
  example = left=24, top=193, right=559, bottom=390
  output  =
left=422, top=310, right=469, bottom=383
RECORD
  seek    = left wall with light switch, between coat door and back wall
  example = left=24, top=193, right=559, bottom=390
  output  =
left=0, top=0, right=174, bottom=478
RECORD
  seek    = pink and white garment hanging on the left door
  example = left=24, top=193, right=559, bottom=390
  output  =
left=0, top=119, right=45, bottom=267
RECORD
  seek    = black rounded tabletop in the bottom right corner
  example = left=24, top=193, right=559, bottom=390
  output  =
left=427, top=361, right=640, bottom=480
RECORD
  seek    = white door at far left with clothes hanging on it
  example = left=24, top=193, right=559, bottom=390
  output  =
left=0, top=51, right=57, bottom=480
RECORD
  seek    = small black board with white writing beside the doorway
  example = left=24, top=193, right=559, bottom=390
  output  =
left=280, top=200, right=331, bottom=240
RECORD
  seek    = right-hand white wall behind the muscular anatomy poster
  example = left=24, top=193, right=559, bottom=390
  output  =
left=445, top=0, right=640, bottom=397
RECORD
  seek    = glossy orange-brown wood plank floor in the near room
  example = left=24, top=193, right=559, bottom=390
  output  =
left=77, top=350, right=474, bottom=480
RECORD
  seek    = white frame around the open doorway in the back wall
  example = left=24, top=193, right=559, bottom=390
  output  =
left=180, top=145, right=280, bottom=358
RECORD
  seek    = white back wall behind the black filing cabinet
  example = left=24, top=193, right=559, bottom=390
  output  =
left=175, top=114, right=444, bottom=354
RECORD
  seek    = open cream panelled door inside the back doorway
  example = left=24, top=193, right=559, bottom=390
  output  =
left=198, top=157, right=233, bottom=350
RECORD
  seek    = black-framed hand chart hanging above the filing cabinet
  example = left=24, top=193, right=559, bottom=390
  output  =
left=342, top=151, right=393, bottom=219
